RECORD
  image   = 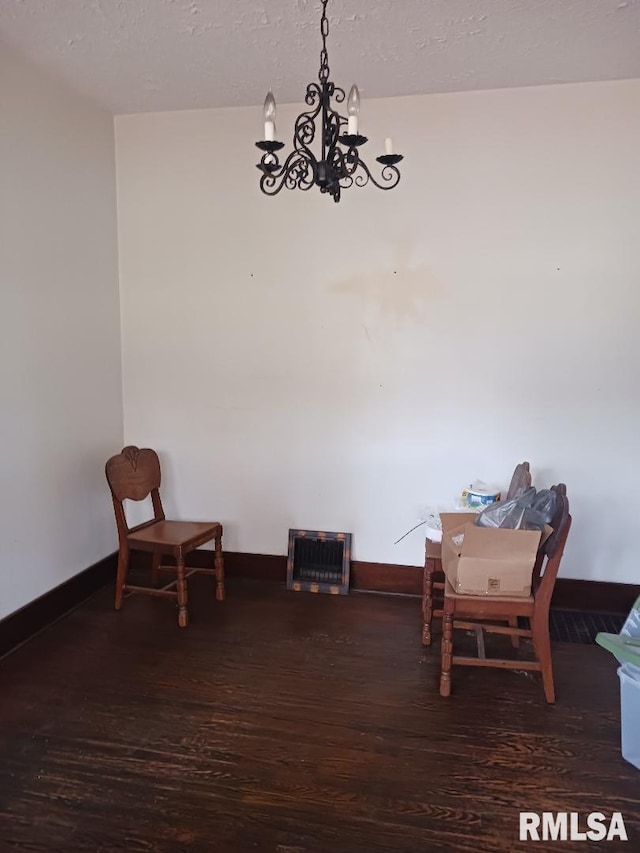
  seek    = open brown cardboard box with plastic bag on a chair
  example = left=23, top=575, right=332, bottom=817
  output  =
left=441, top=513, right=551, bottom=597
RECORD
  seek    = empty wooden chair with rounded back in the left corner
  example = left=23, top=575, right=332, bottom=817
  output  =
left=105, top=446, right=224, bottom=628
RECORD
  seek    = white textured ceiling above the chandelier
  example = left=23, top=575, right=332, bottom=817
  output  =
left=0, top=0, right=640, bottom=113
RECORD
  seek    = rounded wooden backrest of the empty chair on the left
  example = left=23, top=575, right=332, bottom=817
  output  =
left=105, top=445, right=165, bottom=542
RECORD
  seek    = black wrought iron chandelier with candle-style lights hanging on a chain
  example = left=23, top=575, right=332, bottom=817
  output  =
left=256, top=0, right=402, bottom=201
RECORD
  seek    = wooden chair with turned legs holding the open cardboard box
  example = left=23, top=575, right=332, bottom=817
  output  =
left=440, top=483, right=571, bottom=703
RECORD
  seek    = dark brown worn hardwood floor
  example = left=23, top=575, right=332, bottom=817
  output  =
left=0, top=577, right=640, bottom=853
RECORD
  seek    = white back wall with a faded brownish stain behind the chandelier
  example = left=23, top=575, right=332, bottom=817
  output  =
left=116, top=81, right=640, bottom=583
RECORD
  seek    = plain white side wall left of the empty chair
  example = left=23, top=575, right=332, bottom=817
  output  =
left=0, top=46, right=122, bottom=617
